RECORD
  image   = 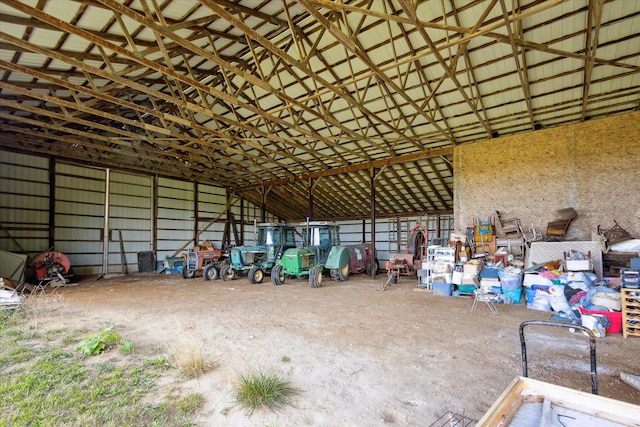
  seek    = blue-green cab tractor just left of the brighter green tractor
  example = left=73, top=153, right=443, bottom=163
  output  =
left=220, top=223, right=296, bottom=284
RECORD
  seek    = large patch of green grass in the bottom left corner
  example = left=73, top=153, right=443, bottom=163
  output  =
left=0, top=312, right=203, bottom=427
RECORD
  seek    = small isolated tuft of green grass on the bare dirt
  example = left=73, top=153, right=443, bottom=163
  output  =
left=235, top=369, right=299, bottom=415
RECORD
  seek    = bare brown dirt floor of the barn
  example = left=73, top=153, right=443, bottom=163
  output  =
left=35, top=274, right=640, bottom=426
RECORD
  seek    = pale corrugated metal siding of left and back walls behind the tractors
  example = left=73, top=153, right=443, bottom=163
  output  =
left=0, top=150, right=453, bottom=275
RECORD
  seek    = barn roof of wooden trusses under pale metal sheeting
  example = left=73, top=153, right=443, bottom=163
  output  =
left=0, top=0, right=640, bottom=220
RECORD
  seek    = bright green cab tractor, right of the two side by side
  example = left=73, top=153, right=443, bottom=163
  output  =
left=271, top=221, right=350, bottom=288
